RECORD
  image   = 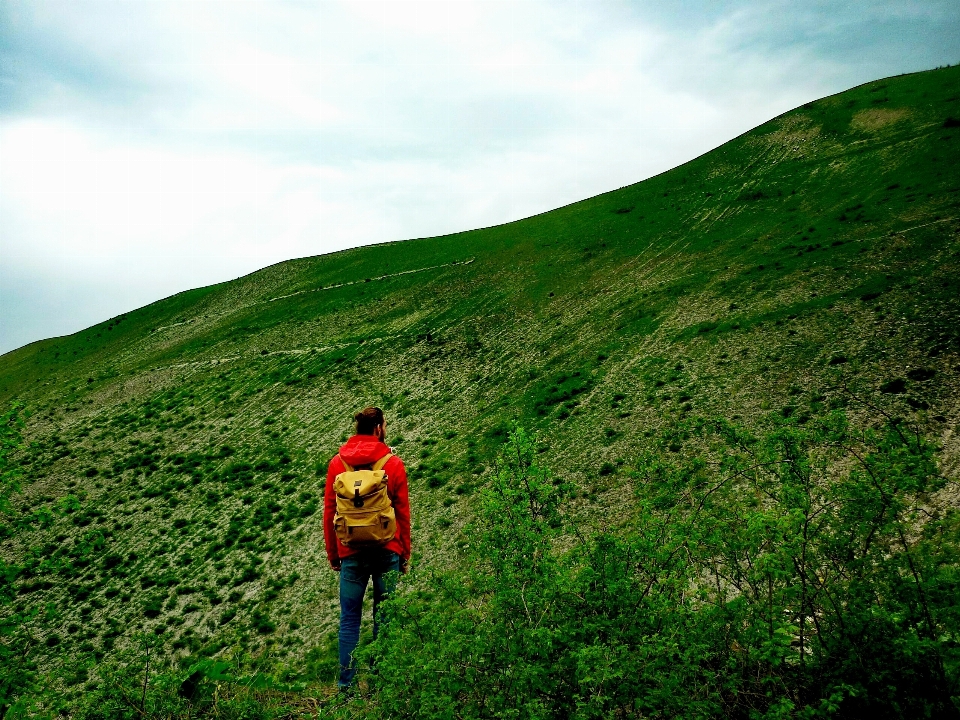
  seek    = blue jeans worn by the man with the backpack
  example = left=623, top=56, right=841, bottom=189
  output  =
left=337, top=548, right=400, bottom=690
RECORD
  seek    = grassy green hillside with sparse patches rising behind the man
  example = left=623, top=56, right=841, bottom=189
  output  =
left=0, top=67, right=960, bottom=702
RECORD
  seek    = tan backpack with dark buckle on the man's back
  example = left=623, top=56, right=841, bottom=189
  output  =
left=333, top=453, right=397, bottom=548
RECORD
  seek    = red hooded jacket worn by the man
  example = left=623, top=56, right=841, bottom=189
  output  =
left=323, top=435, right=410, bottom=567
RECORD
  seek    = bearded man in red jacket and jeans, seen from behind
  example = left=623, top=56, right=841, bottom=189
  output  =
left=323, top=407, right=410, bottom=691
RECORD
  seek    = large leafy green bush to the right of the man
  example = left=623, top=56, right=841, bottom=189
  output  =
left=361, top=414, right=960, bottom=718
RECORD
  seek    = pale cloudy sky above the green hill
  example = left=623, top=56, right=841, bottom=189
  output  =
left=0, top=0, right=960, bottom=353
